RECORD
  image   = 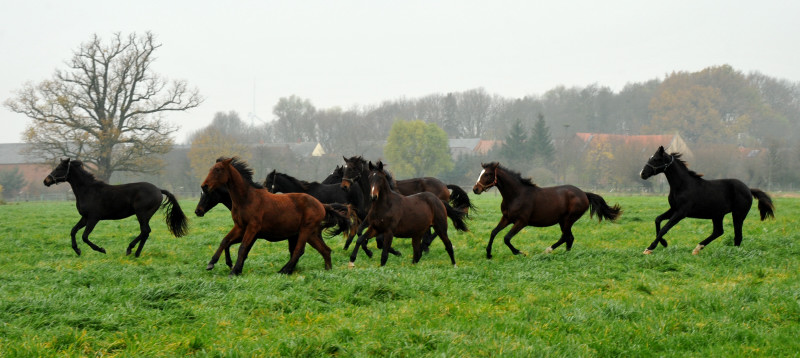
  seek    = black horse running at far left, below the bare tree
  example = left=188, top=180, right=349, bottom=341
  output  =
left=43, top=158, right=188, bottom=257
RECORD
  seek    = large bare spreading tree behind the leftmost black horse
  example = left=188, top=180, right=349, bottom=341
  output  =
left=5, top=32, right=203, bottom=181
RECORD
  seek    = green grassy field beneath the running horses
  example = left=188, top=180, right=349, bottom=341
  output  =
left=0, top=191, right=800, bottom=357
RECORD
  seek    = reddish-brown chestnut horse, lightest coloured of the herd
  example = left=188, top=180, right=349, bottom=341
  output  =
left=202, top=158, right=350, bottom=275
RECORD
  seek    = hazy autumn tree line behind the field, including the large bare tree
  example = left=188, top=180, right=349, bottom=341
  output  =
left=5, top=33, right=800, bottom=196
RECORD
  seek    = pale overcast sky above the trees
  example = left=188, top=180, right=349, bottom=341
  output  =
left=0, top=0, right=800, bottom=143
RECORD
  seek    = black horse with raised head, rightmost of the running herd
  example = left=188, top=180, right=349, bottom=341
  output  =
left=639, top=146, right=775, bottom=255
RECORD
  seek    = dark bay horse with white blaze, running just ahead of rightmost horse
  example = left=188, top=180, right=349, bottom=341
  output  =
left=472, top=162, right=622, bottom=259
